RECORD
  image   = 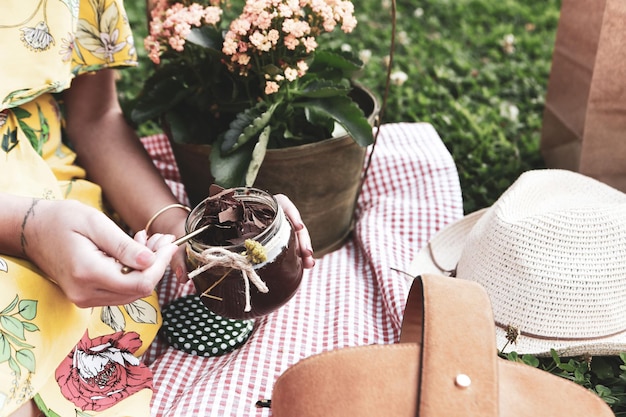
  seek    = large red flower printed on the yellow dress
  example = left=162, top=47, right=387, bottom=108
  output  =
left=56, top=332, right=152, bottom=411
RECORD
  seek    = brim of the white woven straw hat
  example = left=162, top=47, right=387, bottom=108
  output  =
left=407, top=208, right=626, bottom=357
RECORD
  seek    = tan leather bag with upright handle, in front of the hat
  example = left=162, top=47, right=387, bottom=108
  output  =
left=271, top=275, right=613, bottom=417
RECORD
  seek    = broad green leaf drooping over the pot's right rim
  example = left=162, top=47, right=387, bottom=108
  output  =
left=294, top=97, right=374, bottom=146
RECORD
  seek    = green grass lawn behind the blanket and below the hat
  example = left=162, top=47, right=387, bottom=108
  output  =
left=119, top=0, right=626, bottom=410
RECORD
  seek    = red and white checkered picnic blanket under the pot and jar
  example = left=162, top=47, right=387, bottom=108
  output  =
left=142, top=123, right=463, bottom=417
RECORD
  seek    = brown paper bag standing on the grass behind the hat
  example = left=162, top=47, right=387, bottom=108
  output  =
left=541, top=0, right=626, bottom=191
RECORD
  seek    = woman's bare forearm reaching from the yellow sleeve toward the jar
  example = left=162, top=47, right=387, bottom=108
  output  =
left=64, top=70, right=187, bottom=237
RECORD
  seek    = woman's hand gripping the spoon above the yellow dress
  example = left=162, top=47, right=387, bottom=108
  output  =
left=22, top=200, right=178, bottom=307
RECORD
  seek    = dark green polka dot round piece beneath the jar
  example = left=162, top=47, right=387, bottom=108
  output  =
left=161, top=294, right=254, bottom=356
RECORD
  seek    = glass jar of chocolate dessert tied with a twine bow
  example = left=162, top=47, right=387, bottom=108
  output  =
left=185, top=187, right=303, bottom=319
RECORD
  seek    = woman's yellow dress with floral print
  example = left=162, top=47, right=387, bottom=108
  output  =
left=0, top=0, right=161, bottom=417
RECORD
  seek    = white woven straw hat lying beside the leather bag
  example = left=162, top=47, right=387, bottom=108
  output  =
left=409, top=169, right=626, bottom=356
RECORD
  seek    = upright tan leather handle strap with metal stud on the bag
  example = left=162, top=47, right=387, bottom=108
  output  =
left=400, top=275, right=498, bottom=417
